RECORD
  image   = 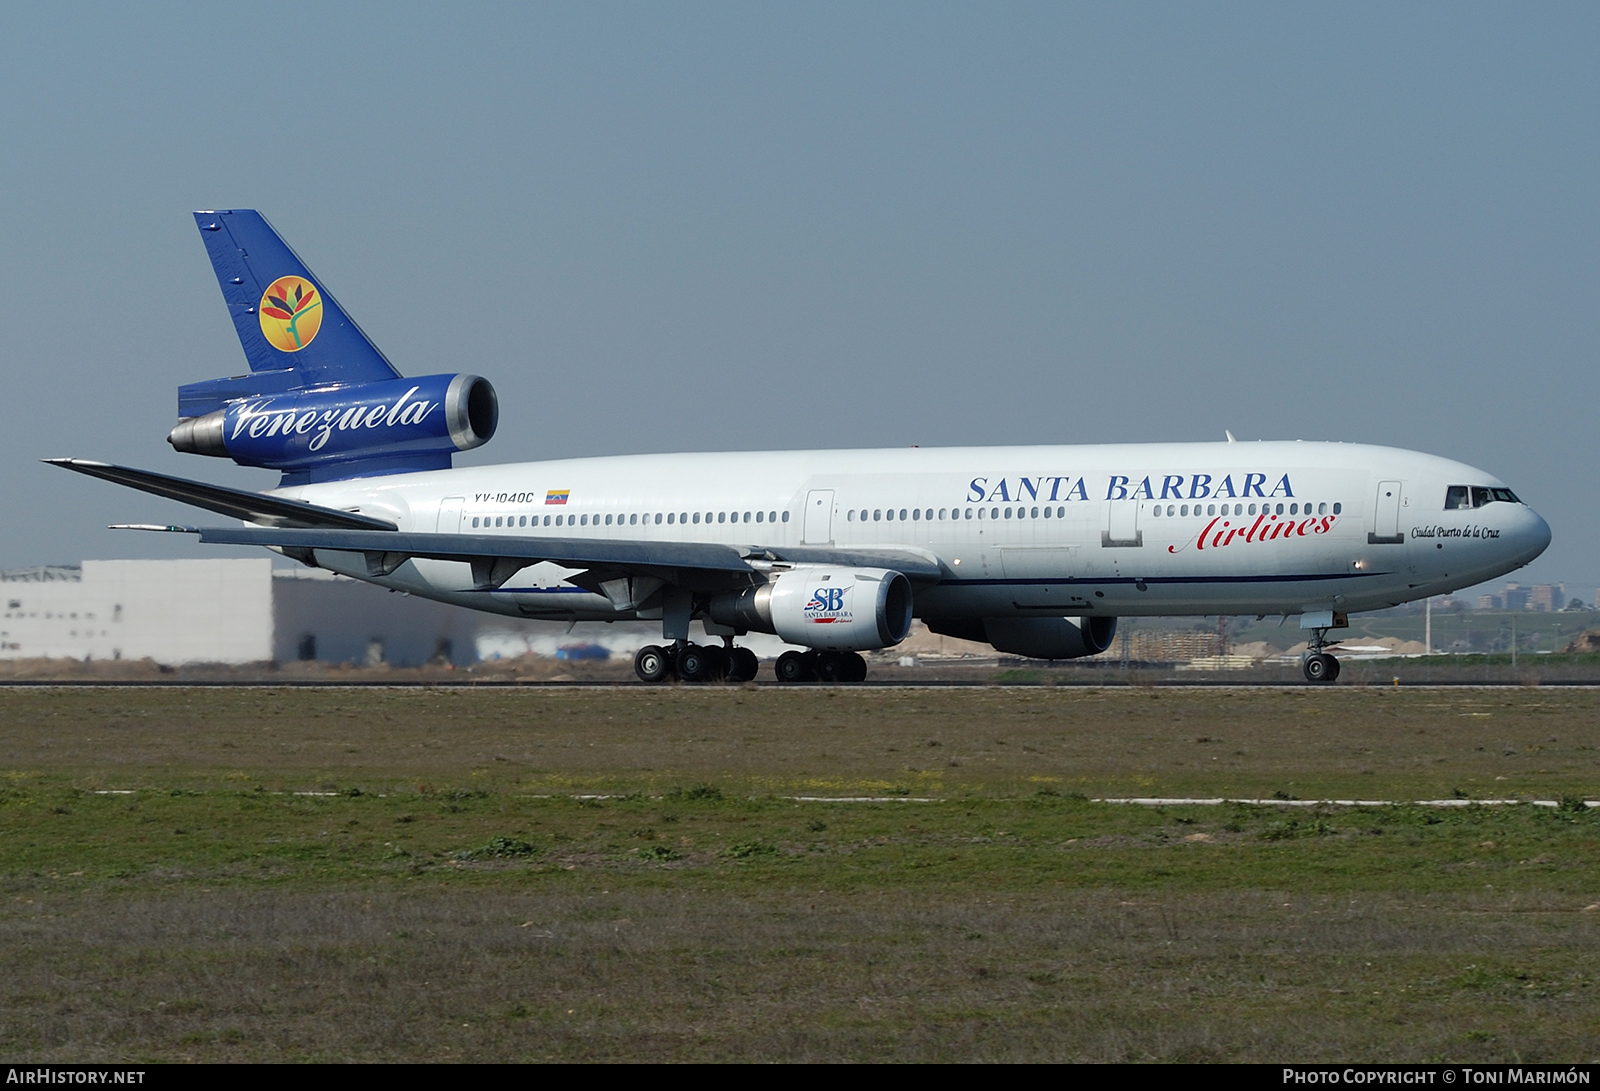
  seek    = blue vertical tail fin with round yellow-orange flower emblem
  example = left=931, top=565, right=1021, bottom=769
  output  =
left=178, top=208, right=400, bottom=418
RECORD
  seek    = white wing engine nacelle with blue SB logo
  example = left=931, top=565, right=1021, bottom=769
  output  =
left=710, top=565, right=912, bottom=651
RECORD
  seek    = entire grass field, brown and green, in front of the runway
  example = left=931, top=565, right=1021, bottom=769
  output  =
left=0, top=686, right=1600, bottom=1062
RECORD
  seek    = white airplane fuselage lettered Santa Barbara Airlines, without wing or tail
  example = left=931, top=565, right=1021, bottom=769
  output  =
left=280, top=442, right=1550, bottom=621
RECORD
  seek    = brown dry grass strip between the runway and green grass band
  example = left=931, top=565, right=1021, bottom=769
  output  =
left=0, top=688, right=1600, bottom=798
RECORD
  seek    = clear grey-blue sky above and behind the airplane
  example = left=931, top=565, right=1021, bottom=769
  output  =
left=0, top=3, right=1600, bottom=601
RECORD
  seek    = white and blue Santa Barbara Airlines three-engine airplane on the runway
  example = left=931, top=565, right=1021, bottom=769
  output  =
left=46, top=210, right=1550, bottom=683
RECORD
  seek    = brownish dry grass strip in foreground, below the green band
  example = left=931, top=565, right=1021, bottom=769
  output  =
left=0, top=886, right=1600, bottom=1061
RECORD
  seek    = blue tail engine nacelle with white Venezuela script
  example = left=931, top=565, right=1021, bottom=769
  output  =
left=166, top=374, right=499, bottom=480
